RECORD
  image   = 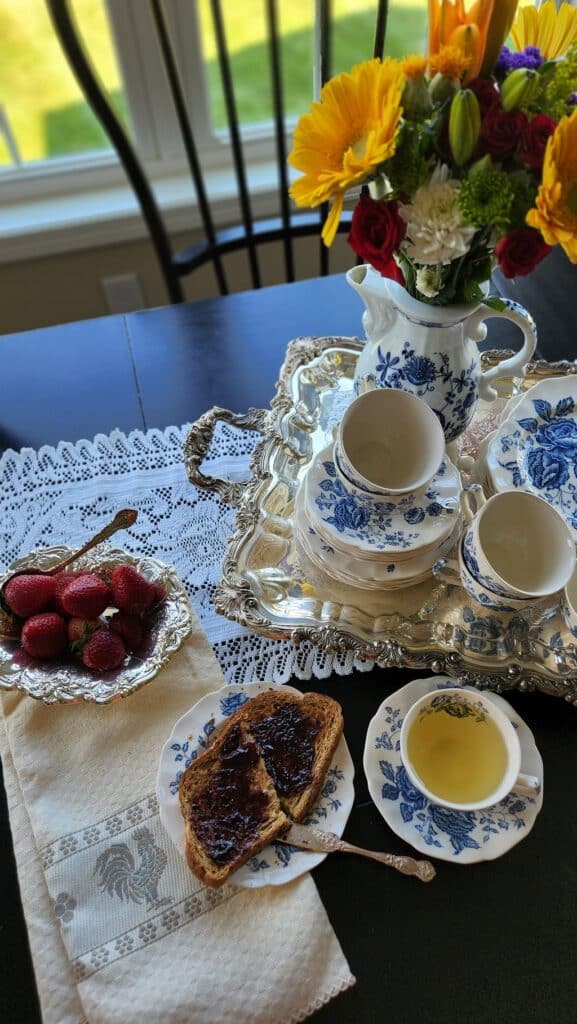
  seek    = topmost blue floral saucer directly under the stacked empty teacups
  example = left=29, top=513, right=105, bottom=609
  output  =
left=304, top=446, right=461, bottom=561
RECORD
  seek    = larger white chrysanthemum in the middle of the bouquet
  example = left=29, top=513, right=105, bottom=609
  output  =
left=399, top=174, right=476, bottom=268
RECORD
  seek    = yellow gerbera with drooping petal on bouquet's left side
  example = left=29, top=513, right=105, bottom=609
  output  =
left=289, top=58, right=405, bottom=246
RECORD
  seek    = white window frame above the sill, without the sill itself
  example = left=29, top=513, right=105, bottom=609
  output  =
left=0, top=0, right=296, bottom=197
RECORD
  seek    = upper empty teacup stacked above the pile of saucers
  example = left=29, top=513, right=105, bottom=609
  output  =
left=335, top=388, right=445, bottom=495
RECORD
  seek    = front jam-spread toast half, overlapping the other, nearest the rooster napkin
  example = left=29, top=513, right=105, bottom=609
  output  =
left=178, top=721, right=290, bottom=887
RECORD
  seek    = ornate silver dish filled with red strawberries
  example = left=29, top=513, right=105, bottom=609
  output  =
left=0, top=545, right=192, bottom=703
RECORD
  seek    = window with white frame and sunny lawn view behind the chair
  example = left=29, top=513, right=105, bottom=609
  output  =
left=0, top=0, right=438, bottom=258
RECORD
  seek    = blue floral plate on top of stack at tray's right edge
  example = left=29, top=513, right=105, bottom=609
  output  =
left=486, top=377, right=577, bottom=540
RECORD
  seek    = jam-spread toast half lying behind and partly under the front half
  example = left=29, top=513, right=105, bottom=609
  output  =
left=214, top=689, right=343, bottom=821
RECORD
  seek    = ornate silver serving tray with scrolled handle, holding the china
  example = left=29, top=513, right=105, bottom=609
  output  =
left=184, top=337, right=577, bottom=702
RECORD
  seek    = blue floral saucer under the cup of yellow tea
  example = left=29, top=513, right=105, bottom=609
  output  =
left=363, top=676, right=543, bottom=864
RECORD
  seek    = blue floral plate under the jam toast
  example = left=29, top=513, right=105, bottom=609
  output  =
left=157, top=683, right=355, bottom=889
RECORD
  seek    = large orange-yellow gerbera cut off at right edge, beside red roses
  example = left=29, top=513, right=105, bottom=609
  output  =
left=527, top=110, right=577, bottom=263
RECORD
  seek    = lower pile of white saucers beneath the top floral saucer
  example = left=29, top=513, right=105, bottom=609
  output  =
left=294, top=487, right=461, bottom=590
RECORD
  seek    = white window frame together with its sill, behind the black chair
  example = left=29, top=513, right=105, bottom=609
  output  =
left=0, top=0, right=307, bottom=263
